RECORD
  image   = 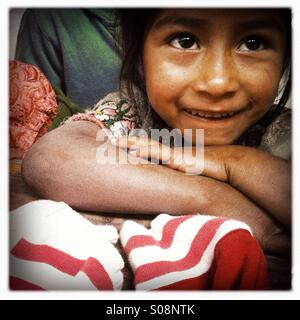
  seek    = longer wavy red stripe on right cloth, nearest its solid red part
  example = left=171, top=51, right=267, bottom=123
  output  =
left=135, top=218, right=226, bottom=284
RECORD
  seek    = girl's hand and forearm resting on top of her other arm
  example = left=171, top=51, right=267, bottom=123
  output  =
left=116, top=137, right=291, bottom=228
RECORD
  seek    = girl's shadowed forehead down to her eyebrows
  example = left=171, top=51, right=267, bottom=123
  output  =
left=153, top=9, right=288, bottom=32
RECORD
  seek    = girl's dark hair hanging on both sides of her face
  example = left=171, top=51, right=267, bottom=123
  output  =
left=115, top=8, right=291, bottom=144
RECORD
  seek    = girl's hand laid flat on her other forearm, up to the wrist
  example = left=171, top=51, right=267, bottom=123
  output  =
left=111, top=136, right=230, bottom=182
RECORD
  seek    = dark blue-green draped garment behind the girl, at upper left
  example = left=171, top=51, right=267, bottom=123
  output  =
left=15, top=8, right=120, bottom=108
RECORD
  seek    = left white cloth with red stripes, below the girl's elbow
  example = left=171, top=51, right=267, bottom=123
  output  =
left=10, top=200, right=124, bottom=290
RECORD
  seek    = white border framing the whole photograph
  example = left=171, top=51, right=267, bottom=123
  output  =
left=0, top=0, right=300, bottom=303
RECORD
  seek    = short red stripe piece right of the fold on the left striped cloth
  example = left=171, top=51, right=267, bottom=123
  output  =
left=81, top=258, right=113, bottom=290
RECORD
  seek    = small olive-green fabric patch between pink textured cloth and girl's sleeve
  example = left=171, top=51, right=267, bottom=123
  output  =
left=48, top=86, right=84, bottom=131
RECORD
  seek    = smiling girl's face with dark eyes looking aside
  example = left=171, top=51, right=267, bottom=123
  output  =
left=143, top=9, right=286, bottom=145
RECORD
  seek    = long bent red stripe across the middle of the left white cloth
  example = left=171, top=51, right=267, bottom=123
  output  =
left=11, top=239, right=113, bottom=290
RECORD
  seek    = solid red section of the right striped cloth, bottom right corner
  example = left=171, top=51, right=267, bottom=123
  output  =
left=156, top=229, right=268, bottom=290
